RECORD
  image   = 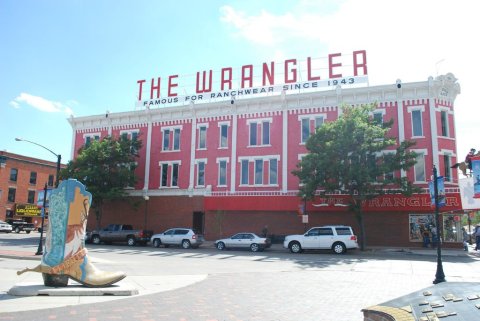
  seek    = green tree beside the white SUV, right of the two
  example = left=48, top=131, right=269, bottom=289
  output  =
left=292, top=104, right=418, bottom=250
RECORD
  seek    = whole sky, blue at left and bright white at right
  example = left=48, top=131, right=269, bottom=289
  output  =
left=0, top=0, right=480, bottom=162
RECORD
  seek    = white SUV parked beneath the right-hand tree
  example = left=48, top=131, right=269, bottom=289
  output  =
left=283, top=225, right=358, bottom=254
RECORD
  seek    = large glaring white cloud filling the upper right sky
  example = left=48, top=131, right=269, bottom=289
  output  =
left=221, top=0, right=480, bottom=158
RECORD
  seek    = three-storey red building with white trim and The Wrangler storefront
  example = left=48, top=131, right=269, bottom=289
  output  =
left=70, top=74, right=462, bottom=246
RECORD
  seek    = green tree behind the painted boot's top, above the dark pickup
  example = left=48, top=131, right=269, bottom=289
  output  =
left=60, top=136, right=142, bottom=228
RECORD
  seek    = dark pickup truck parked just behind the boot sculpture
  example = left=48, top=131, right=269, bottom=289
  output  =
left=87, top=224, right=153, bottom=246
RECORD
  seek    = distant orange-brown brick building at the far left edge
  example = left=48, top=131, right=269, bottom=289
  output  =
left=0, top=151, right=61, bottom=226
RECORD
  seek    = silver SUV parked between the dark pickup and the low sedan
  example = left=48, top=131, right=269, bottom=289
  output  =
left=150, top=227, right=205, bottom=249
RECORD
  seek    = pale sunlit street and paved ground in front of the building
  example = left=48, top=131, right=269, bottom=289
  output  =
left=0, top=233, right=480, bottom=321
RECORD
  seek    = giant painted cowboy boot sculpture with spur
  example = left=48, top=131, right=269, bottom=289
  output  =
left=17, top=179, right=126, bottom=287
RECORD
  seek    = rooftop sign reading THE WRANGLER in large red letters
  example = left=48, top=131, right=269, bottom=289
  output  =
left=136, top=50, right=368, bottom=108
